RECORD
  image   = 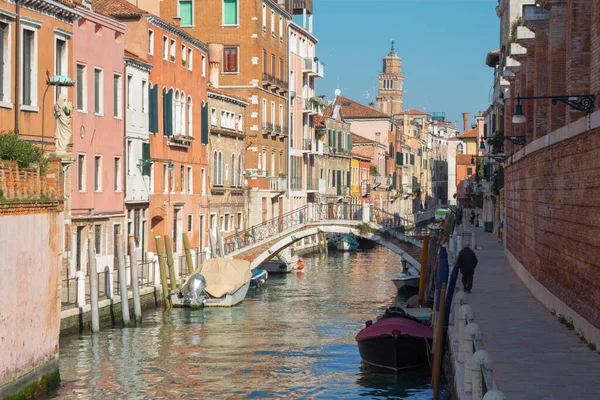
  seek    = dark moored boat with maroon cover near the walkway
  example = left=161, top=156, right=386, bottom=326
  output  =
left=356, top=307, right=433, bottom=372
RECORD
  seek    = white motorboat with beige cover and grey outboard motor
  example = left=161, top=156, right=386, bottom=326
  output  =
left=171, top=258, right=252, bottom=307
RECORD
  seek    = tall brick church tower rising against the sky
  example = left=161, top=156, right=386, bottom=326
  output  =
left=376, top=40, right=404, bottom=116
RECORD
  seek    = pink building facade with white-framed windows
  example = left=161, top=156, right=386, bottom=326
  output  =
left=65, top=8, right=128, bottom=277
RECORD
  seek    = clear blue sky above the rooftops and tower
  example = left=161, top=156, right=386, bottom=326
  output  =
left=313, top=0, right=500, bottom=128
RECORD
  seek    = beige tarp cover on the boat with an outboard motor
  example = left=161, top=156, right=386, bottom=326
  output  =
left=196, top=257, right=252, bottom=298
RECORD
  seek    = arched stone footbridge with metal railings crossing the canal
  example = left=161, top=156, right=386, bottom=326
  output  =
left=217, top=203, right=433, bottom=268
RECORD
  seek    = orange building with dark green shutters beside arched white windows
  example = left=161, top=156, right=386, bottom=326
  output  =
left=94, top=0, right=209, bottom=259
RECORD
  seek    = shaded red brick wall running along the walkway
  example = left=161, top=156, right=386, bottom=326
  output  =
left=505, top=129, right=600, bottom=328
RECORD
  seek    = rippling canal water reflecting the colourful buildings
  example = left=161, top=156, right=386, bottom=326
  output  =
left=49, top=247, right=440, bottom=399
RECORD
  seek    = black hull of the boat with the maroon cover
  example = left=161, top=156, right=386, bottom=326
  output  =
left=357, top=335, right=431, bottom=372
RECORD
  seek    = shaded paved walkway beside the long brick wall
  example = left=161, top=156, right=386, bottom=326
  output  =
left=461, top=228, right=600, bottom=400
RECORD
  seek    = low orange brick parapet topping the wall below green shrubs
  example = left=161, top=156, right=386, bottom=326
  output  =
left=0, top=158, right=64, bottom=205
